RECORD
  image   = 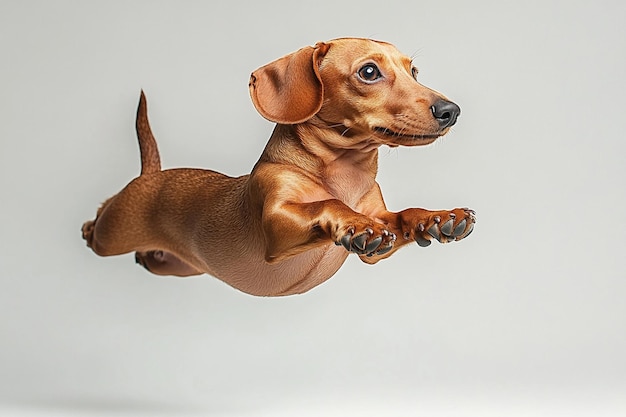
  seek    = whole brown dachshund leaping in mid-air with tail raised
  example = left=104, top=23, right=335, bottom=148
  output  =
left=82, top=38, right=475, bottom=296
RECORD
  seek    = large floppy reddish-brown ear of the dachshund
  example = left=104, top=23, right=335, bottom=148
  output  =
left=249, top=42, right=330, bottom=124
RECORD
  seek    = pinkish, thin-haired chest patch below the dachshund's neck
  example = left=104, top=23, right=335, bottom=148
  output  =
left=324, top=160, right=375, bottom=209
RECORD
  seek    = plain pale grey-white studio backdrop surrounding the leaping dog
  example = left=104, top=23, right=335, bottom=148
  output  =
left=0, top=0, right=626, bottom=416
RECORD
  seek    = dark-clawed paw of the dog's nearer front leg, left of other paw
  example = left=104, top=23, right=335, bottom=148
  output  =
left=335, top=225, right=396, bottom=256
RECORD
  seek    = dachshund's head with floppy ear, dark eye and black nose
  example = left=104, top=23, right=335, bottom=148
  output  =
left=249, top=38, right=460, bottom=148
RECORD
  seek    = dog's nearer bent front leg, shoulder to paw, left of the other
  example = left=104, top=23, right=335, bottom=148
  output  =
left=263, top=199, right=396, bottom=263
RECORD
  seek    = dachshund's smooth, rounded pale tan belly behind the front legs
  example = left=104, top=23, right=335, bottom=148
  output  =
left=209, top=244, right=348, bottom=296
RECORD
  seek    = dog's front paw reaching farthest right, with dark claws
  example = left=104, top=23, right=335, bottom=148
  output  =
left=414, top=208, right=476, bottom=247
